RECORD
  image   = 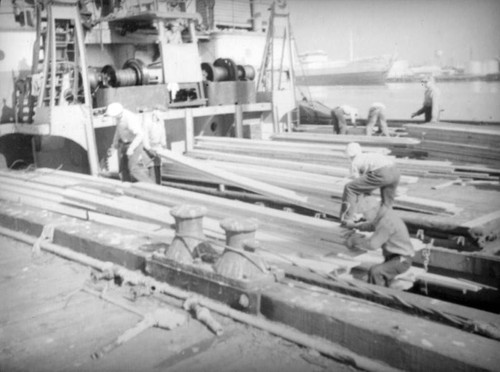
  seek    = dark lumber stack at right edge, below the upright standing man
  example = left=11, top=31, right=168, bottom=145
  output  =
left=405, top=123, right=500, bottom=167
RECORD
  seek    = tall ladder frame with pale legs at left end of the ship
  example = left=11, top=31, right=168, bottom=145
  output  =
left=24, top=0, right=99, bottom=175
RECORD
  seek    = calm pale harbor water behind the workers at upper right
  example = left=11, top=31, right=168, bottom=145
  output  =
left=299, top=81, right=500, bottom=122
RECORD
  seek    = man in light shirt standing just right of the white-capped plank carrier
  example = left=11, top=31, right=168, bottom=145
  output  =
left=142, top=106, right=167, bottom=185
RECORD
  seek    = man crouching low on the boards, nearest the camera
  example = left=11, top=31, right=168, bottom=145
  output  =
left=346, top=197, right=415, bottom=287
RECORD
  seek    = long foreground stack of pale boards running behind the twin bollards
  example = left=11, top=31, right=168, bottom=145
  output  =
left=0, top=169, right=496, bottom=300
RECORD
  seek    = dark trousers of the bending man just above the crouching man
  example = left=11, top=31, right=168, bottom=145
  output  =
left=340, top=166, right=400, bottom=221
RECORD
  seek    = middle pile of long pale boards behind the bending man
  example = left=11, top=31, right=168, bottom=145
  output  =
left=186, top=137, right=460, bottom=215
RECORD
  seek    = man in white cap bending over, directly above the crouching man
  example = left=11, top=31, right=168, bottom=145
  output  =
left=340, top=142, right=400, bottom=227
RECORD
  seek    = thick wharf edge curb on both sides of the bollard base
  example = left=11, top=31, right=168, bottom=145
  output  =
left=0, top=203, right=500, bottom=371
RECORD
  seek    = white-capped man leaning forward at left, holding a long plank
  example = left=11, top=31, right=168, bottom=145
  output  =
left=106, top=102, right=152, bottom=183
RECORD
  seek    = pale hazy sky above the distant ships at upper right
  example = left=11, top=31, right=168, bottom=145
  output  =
left=288, top=0, right=500, bottom=66
